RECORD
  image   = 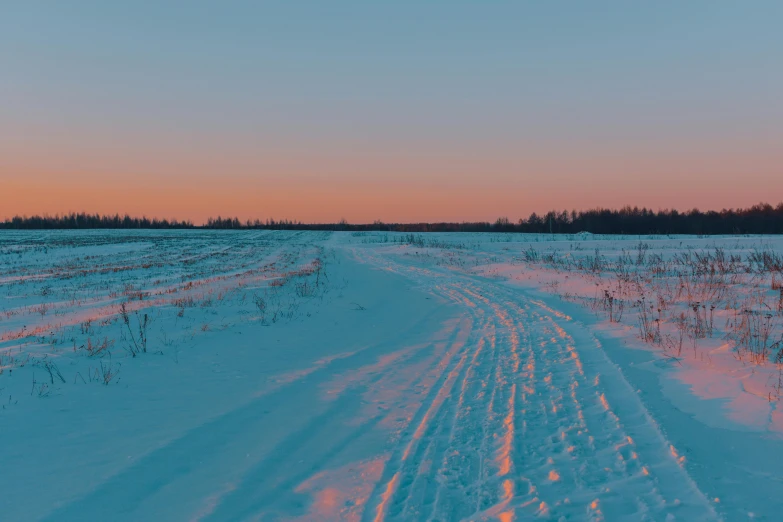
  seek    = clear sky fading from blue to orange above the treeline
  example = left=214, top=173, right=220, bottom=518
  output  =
left=0, top=0, right=783, bottom=222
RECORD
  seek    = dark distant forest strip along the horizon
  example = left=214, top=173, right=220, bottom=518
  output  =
left=0, top=203, right=783, bottom=235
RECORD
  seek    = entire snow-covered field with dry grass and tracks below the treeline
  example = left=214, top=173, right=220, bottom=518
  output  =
left=0, top=231, right=783, bottom=521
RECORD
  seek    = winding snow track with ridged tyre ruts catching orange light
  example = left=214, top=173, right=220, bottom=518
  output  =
left=359, top=251, right=717, bottom=520
